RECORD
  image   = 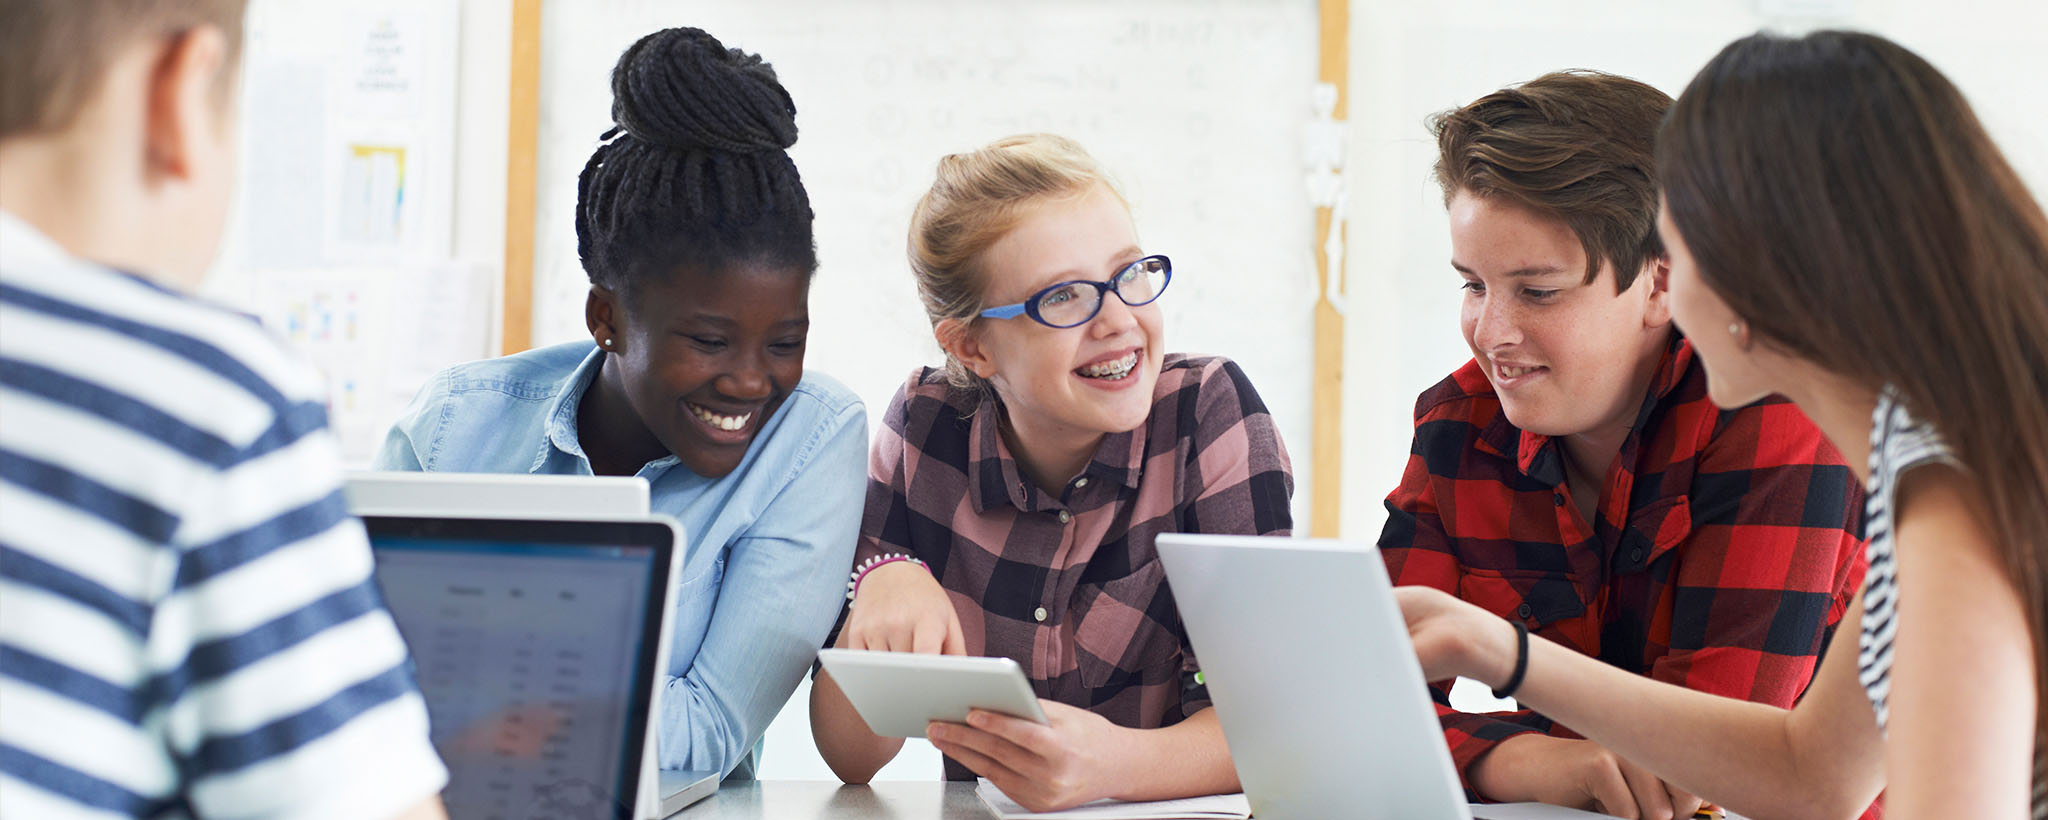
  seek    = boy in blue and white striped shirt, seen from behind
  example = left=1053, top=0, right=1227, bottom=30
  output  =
left=0, top=0, right=446, bottom=818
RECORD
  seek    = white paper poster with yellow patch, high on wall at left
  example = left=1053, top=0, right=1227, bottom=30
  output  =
left=227, top=0, right=461, bottom=271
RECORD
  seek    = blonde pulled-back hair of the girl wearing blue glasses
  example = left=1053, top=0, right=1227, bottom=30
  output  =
left=909, top=133, right=1122, bottom=392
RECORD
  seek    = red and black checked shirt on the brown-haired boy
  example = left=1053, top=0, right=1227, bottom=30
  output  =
left=1380, top=338, right=1864, bottom=799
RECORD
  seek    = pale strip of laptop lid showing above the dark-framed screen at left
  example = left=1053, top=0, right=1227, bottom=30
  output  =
left=342, top=469, right=647, bottom=519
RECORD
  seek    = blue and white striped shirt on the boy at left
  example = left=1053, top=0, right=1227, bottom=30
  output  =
left=0, top=213, right=446, bottom=818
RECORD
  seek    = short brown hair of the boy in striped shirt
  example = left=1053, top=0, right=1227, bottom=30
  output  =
left=0, top=0, right=248, bottom=139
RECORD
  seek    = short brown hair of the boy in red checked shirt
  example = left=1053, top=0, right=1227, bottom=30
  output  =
left=1430, top=70, right=1671, bottom=291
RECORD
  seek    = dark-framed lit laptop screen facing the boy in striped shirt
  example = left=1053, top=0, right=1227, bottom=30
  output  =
left=362, top=515, right=680, bottom=820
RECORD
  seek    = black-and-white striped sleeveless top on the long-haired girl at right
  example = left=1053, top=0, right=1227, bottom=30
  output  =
left=1855, top=387, right=2048, bottom=820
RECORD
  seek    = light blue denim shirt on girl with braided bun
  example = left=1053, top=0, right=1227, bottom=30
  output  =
left=377, top=342, right=868, bottom=777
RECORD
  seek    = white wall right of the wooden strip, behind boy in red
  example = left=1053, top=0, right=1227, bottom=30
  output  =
left=1343, top=0, right=2048, bottom=539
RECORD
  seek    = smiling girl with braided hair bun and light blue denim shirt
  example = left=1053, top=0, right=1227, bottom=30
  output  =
left=377, top=29, right=868, bottom=775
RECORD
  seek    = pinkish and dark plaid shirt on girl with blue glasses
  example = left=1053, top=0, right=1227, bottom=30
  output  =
left=842, top=355, right=1294, bottom=779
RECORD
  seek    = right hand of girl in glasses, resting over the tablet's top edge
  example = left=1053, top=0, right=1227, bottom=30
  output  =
left=838, top=562, right=967, bottom=654
